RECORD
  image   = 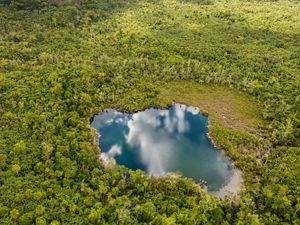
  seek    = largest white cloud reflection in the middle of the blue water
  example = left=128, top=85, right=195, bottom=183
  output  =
left=126, top=104, right=196, bottom=175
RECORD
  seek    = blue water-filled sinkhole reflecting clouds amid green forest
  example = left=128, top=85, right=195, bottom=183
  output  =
left=92, top=104, right=239, bottom=192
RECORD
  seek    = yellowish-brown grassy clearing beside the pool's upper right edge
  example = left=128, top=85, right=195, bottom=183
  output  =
left=159, top=82, right=266, bottom=133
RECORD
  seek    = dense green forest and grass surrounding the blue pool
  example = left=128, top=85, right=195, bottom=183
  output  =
left=0, top=0, right=300, bottom=225
